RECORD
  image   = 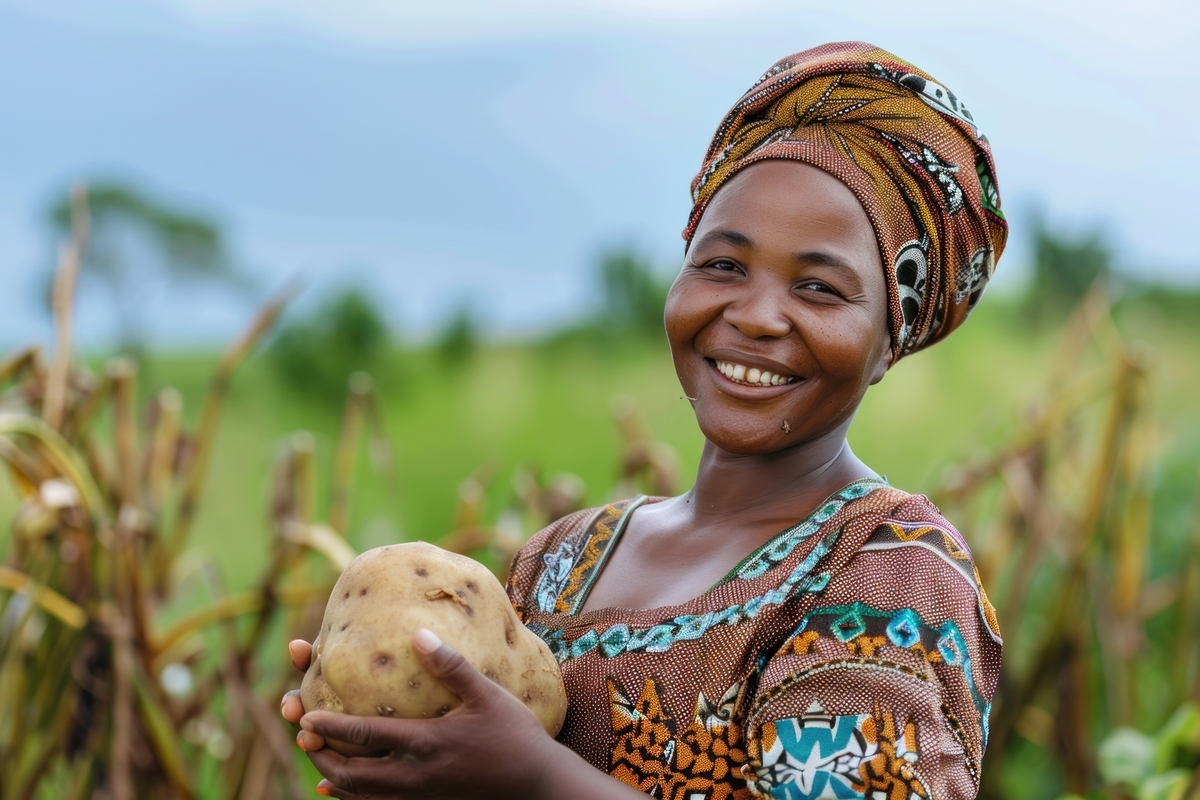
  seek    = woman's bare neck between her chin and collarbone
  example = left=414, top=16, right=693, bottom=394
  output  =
left=682, top=421, right=875, bottom=524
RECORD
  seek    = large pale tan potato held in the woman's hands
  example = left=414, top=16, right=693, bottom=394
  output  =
left=300, top=542, right=566, bottom=756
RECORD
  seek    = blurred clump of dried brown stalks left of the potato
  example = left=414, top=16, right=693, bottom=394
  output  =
left=0, top=188, right=388, bottom=800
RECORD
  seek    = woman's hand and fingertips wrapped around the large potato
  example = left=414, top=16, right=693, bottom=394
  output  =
left=282, top=630, right=565, bottom=800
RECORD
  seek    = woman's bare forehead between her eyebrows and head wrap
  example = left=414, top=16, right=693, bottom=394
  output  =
left=694, top=158, right=881, bottom=265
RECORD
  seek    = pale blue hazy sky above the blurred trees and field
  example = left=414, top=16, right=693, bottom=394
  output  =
left=0, top=0, right=1200, bottom=349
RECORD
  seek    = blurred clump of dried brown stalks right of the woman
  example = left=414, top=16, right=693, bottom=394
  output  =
left=936, top=287, right=1200, bottom=798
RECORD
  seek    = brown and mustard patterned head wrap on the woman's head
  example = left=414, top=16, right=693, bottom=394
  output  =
left=683, top=42, right=1008, bottom=359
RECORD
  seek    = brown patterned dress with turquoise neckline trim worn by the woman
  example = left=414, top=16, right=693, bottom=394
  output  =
left=509, top=479, right=1001, bottom=800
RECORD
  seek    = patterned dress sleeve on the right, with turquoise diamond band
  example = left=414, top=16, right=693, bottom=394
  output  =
left=743, top=519, right=1002, bottom=800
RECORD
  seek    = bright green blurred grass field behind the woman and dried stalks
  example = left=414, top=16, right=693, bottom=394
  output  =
left=0, top=301, right=1200, bottom=798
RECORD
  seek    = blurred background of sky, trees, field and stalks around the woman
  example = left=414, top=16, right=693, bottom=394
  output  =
left=0, top=0, right=1200, bottom=800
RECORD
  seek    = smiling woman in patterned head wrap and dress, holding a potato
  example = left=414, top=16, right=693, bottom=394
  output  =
left=284, top=43, right=1007, bottom=800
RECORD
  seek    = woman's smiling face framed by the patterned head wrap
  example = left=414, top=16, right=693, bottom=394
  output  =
left=666, top=160, right=892, bottom=455
